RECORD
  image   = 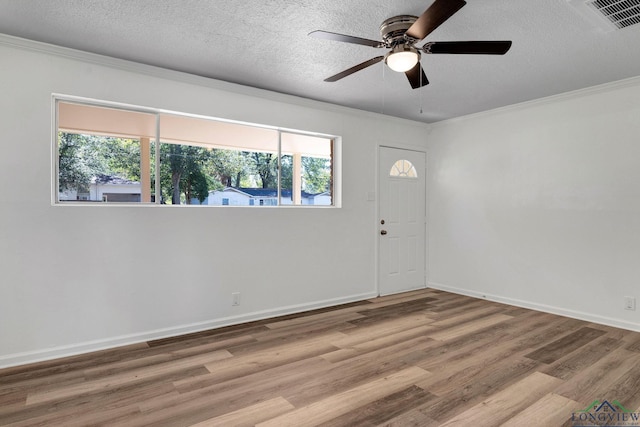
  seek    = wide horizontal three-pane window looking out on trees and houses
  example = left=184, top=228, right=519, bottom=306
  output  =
left=55, top=99, right=335, bottom=206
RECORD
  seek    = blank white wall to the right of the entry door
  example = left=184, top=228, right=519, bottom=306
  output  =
left=428, top=79, right=640, bottom=330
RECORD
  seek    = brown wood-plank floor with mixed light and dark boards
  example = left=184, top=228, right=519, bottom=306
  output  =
left=0, top=289, right=640, bottom=427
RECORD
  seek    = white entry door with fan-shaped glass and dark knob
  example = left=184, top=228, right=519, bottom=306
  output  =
left=378, top=147, right=427, bottom=295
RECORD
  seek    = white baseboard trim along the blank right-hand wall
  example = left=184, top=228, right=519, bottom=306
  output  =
left=428, top=282, right=640, bottom=332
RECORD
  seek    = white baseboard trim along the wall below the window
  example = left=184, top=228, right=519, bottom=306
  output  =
left=0, top=292, right=378, bottom=369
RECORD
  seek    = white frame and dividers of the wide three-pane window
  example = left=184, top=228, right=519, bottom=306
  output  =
left=51, top=93, right=342, bottom=208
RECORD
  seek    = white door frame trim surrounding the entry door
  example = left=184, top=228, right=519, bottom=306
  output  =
left=373, top=142, right=429, bottom=296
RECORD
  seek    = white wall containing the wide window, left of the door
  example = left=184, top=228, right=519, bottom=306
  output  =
left=0, top=36, right=427, bottom=366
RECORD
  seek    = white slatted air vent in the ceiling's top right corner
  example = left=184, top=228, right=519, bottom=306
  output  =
left=568, top=0, right=640, bottom=31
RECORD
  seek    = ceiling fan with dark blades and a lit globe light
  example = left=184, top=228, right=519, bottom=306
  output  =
left=309, top=0, right=511, bottom=89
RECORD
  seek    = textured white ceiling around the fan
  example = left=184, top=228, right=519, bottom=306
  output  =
left=0, top=0, right=640, bottom=122
